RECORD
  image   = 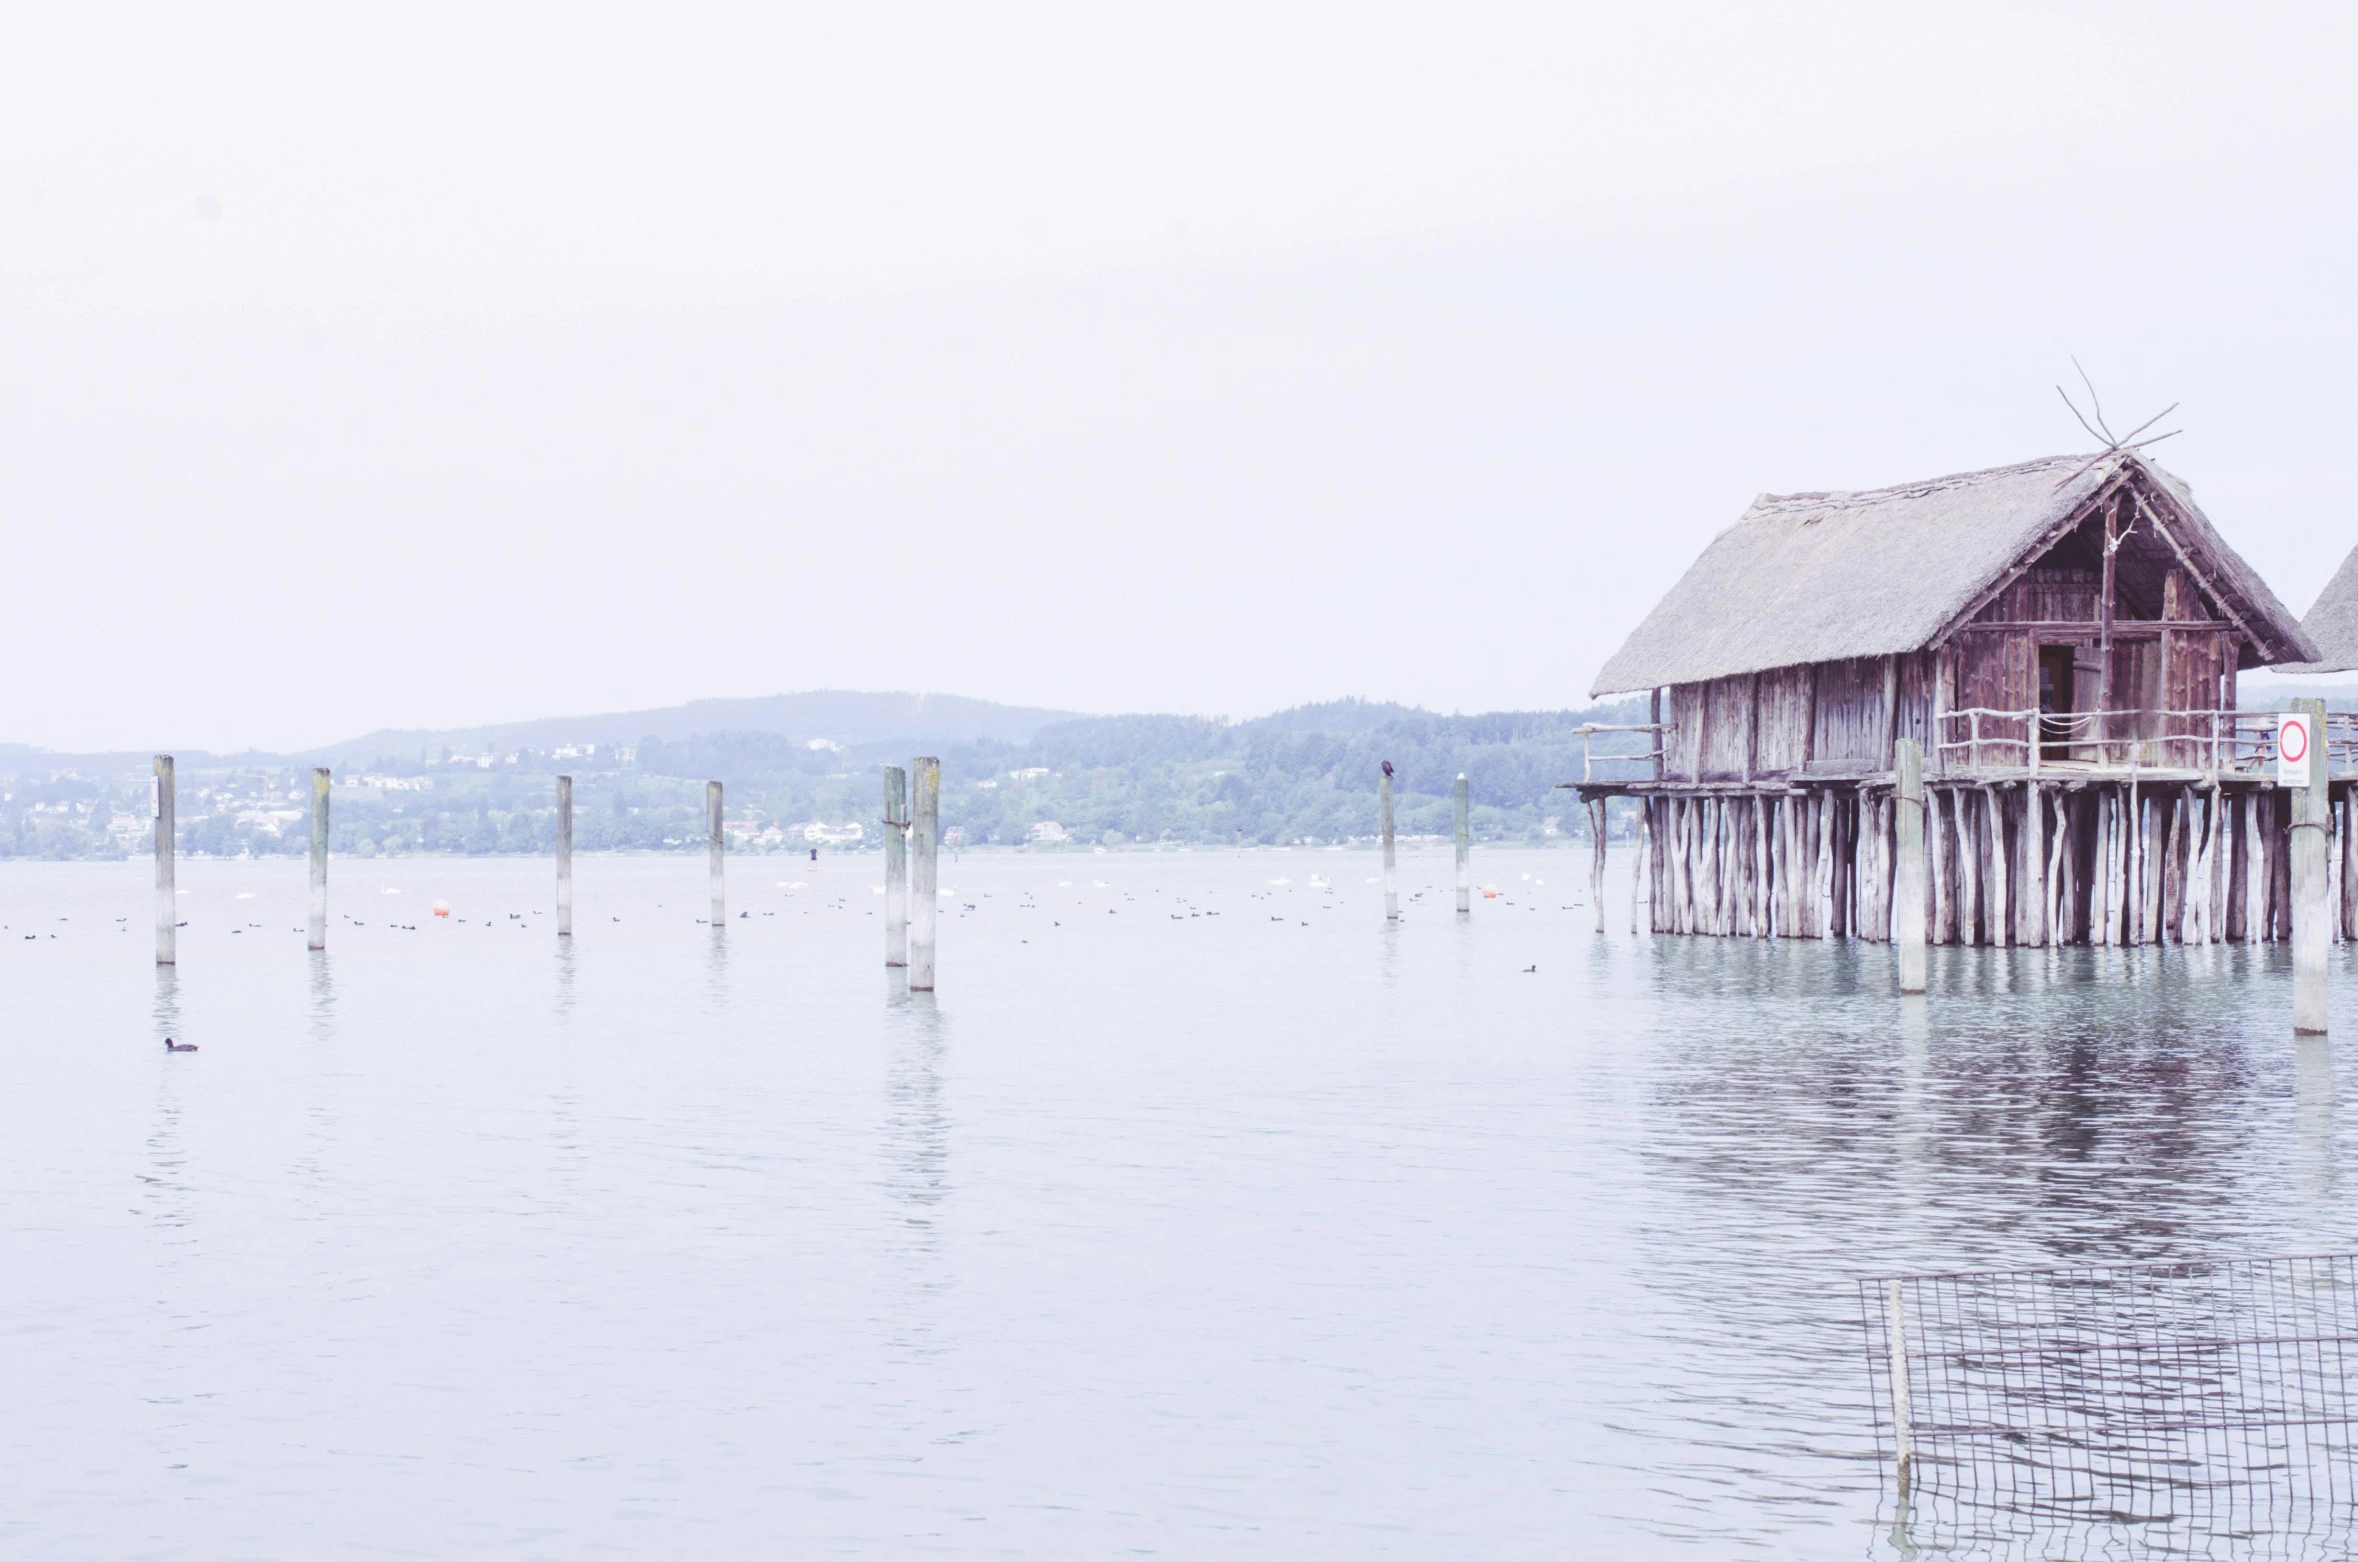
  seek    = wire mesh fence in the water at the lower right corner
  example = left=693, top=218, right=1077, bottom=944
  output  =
left=1858, top=1253, right=2358, bottom=1541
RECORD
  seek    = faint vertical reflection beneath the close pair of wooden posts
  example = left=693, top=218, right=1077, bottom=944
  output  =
left=884, top=995, right=950, bottom=1357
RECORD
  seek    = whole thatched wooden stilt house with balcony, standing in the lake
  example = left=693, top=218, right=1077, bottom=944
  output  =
left=1568, top=451, right=2358, bottom=946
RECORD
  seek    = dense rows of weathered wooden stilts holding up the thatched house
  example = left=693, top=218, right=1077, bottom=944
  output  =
left=1636, top=781, right=2358, bottom=946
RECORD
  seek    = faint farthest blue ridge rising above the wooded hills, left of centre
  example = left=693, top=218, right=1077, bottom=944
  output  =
left=288, top=689, right=1080, bottom=769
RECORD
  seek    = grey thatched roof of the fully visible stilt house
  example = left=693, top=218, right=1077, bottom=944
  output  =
left=1589, top=453, right=2313, bottom=696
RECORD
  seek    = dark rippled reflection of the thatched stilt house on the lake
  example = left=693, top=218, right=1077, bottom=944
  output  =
left=1641, top=939, right=2353, bottom=1555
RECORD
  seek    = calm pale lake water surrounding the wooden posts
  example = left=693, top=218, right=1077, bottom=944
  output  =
left=0, top=852, right=2358, bottom=1560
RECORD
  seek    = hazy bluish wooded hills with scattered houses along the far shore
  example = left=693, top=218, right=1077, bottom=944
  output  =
left=0, top=691, right=1646, bottom=857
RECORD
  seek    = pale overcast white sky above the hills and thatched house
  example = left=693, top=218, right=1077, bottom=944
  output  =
left=0, top=2, right=2358, bottom=748
